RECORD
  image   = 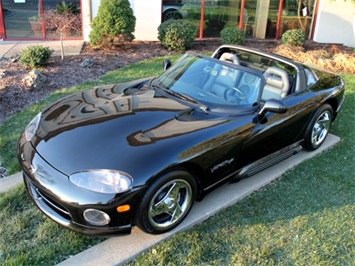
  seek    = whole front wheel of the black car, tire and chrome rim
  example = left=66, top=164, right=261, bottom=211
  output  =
left=135, top=170, right=196, bottom=234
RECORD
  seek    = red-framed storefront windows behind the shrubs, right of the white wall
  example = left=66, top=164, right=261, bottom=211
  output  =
left=162, top=0, right=315, bottom=39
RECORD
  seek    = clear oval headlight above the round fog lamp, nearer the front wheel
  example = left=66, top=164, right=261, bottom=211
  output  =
left=69, top=170, right=133, bottom=194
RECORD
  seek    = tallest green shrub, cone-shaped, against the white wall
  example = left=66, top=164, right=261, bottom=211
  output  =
left=89, top=0, right=136, bottom=46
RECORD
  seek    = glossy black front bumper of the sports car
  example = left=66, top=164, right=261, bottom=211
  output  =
left=18, top=136, right=140, bottom=236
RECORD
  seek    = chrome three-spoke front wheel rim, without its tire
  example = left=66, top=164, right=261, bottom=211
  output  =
left=148, top=179, right=193, bottom=229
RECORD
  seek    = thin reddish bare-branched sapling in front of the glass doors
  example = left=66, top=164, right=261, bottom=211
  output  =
left=44, top=10, right=81, bottom=60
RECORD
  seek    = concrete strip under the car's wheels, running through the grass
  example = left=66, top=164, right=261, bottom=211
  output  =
left=58, top=135, right=340, bottom=266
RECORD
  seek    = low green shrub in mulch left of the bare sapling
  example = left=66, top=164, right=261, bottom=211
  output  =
left=19, top=45, right=53, bottom=68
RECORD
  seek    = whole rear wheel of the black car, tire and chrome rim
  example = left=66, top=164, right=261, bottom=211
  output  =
left=303, top=104, right=333, bottom=151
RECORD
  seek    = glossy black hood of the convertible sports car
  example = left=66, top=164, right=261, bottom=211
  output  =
left=32, top=84, right=225, bottom=184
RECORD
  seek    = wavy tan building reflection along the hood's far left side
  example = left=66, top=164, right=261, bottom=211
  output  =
left=37, top=84, right=186, bottom=139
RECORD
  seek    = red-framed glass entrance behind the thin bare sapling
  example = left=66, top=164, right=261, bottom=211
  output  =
left=0, top=0, right=82, bottom=39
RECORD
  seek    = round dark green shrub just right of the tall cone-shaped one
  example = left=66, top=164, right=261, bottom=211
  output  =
left=158, top=19, right=196, bottom=51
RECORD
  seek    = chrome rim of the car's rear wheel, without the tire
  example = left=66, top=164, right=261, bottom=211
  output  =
left=311, top=110, right=332, bottom=146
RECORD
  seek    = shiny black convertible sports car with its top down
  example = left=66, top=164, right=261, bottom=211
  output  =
left=18, top=46, right=344, bottom=236
